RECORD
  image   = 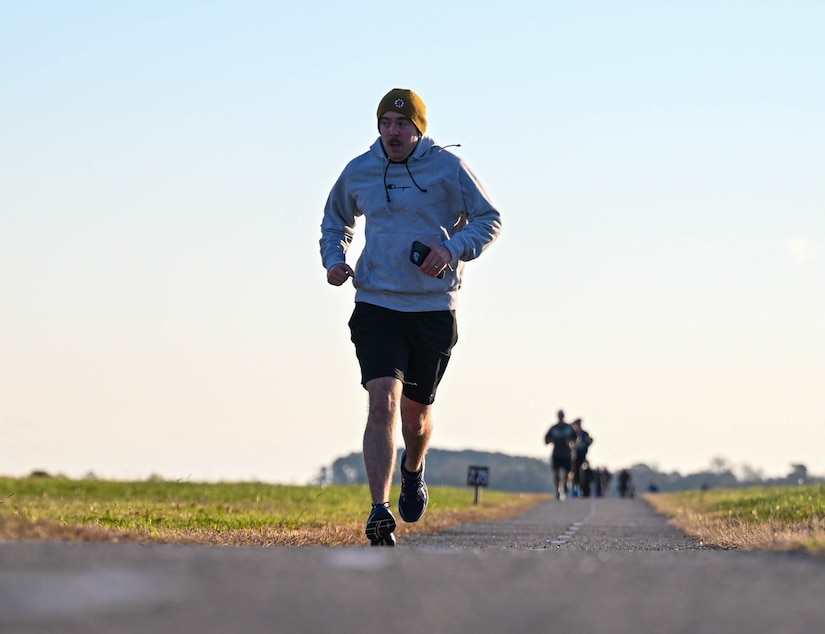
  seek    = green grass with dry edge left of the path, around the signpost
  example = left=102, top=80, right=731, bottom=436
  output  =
left=0, top=477, right=540, bottom=544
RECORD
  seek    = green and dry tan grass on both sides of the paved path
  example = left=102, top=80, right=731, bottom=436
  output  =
left=0, top=477, right=825, bottom=553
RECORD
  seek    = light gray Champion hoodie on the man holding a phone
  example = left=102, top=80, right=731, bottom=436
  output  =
left=320, top=136, right=501, bottom=312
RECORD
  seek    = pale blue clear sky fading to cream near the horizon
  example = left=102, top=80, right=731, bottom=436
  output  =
left=0, top=1, right=825, bottom=483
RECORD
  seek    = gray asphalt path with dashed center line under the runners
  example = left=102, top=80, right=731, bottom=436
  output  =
left=0, top=499, right=825, bottom=634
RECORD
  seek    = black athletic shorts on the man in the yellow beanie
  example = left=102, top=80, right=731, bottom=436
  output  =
left=349, top=302, right=458, bottom=405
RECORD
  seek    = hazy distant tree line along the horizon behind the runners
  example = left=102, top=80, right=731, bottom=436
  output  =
left=315, top=449, right=825, bottom=495
